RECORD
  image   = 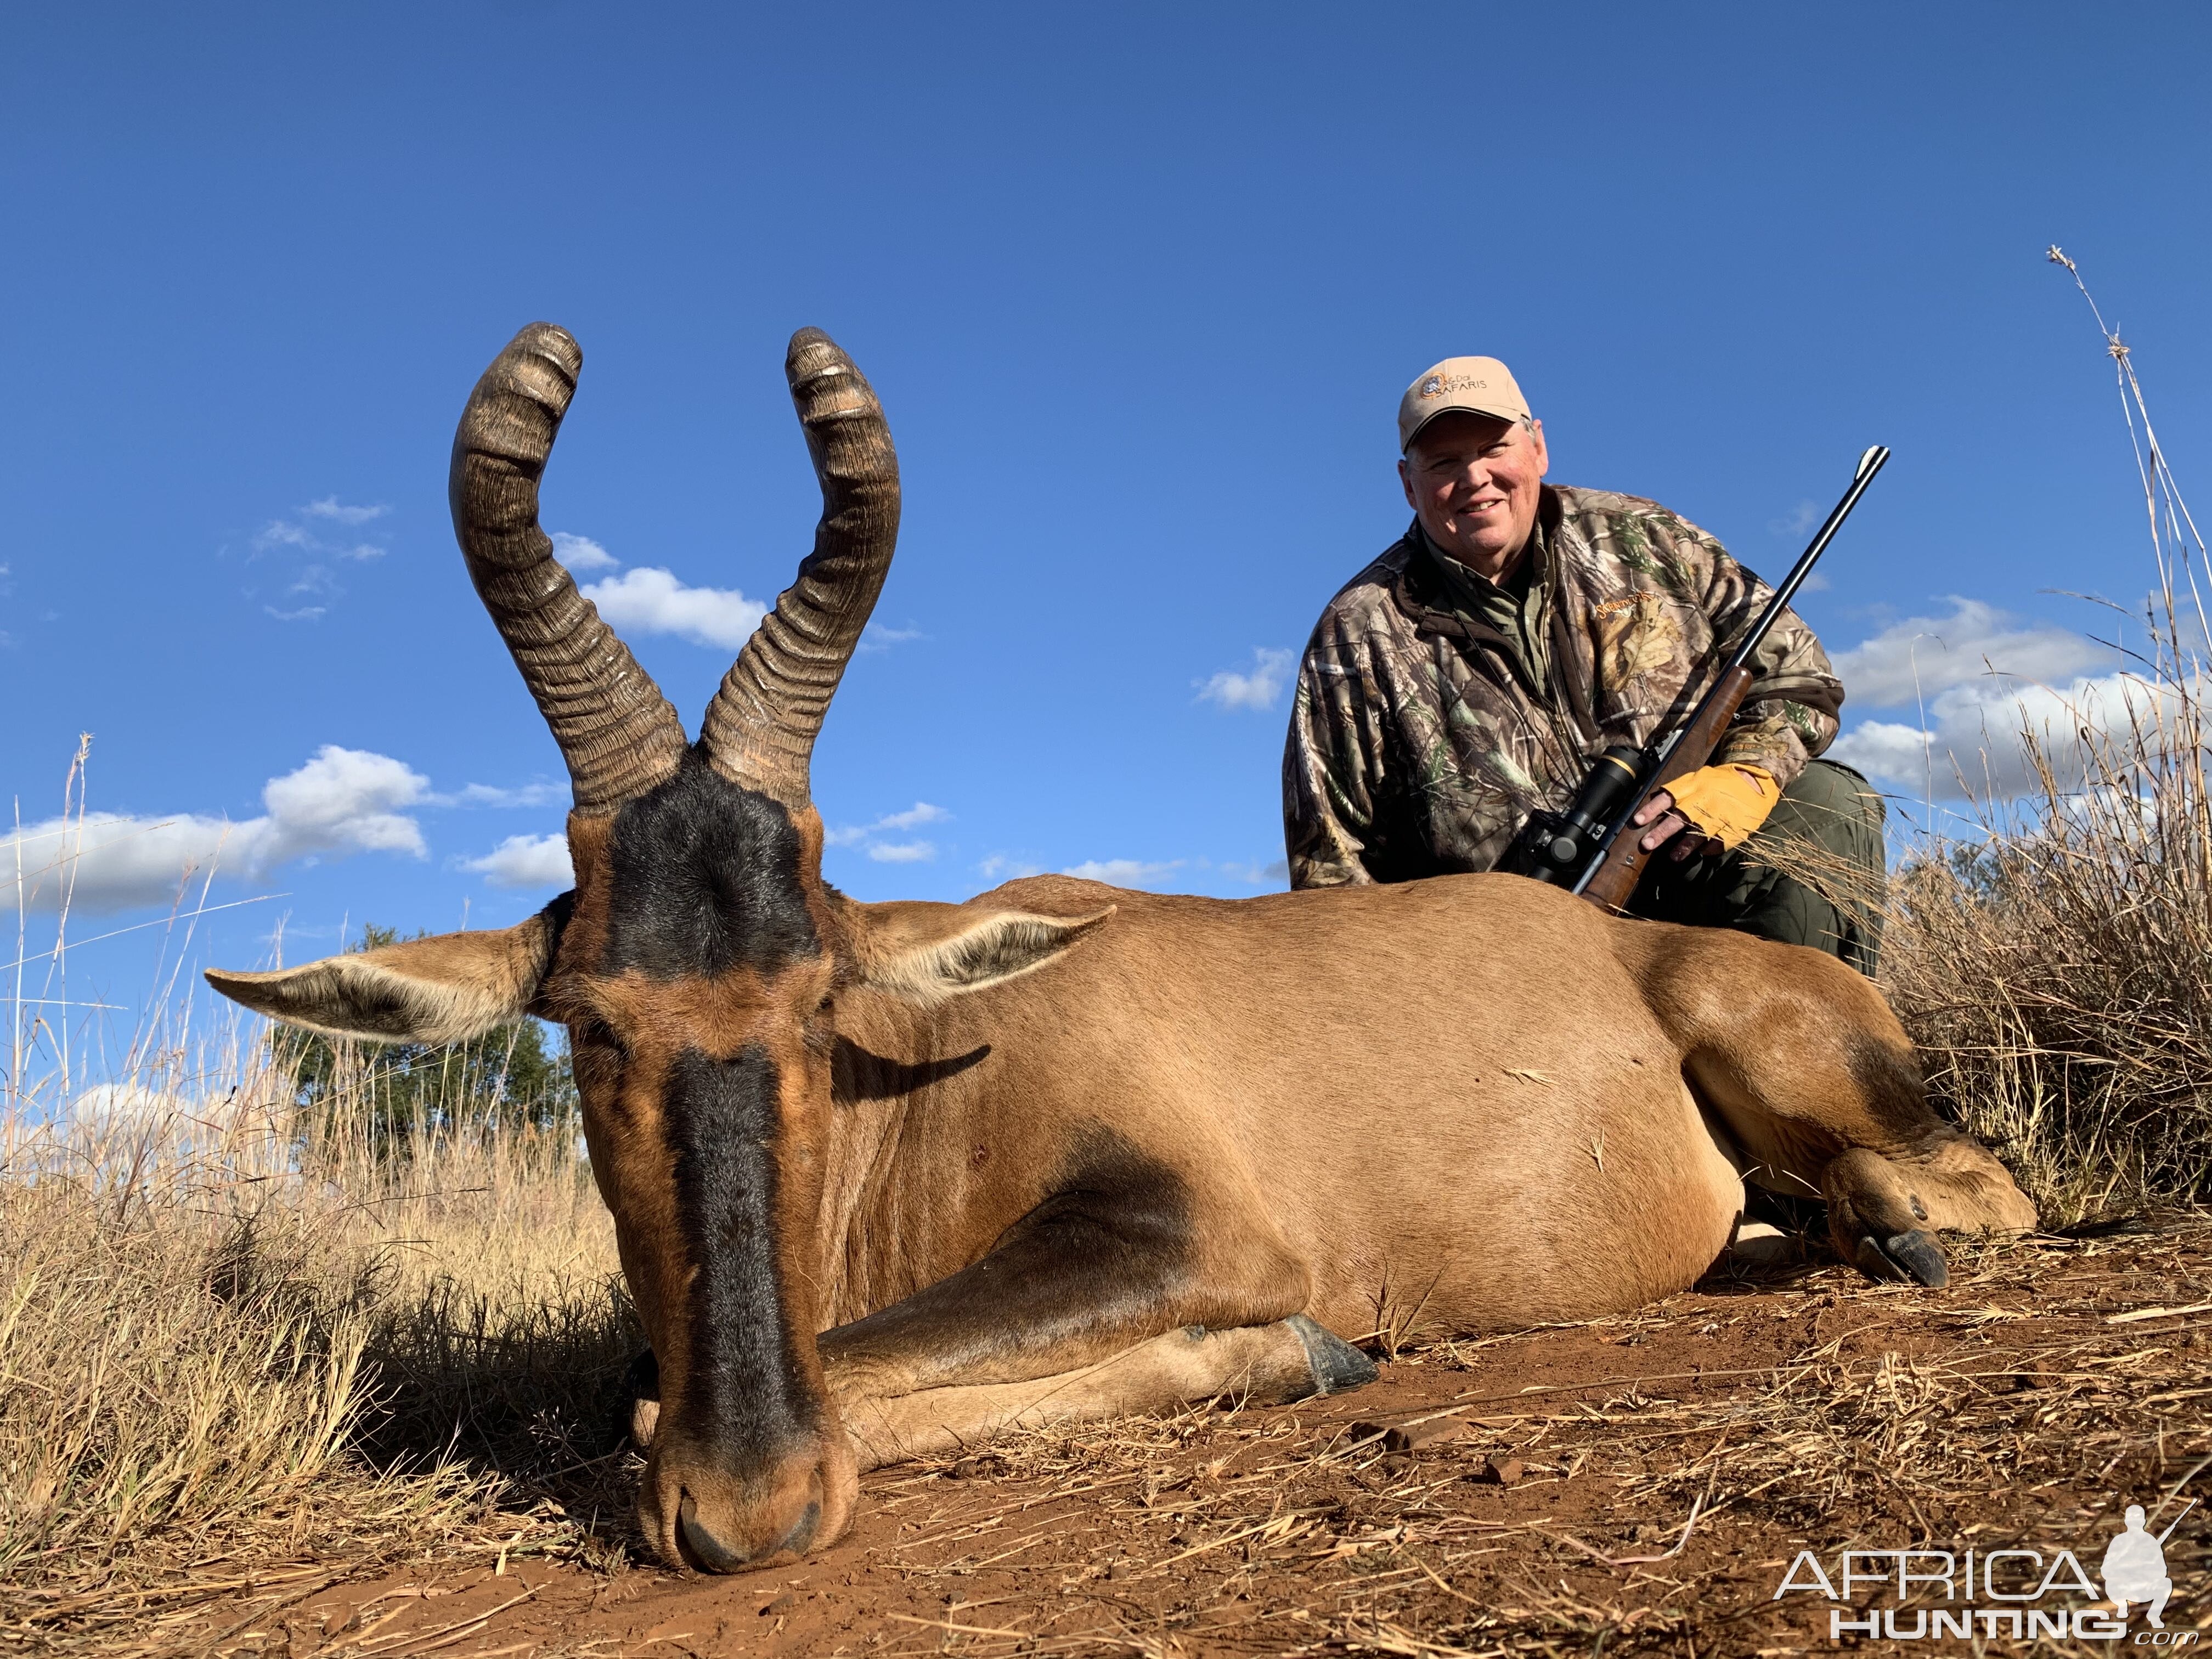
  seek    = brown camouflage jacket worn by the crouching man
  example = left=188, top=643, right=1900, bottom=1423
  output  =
left=1283, top=484, right=1843, bottom=887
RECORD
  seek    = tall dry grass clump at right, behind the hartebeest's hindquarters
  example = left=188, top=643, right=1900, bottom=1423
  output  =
left=1884, top=738, right=2212, bottom=1221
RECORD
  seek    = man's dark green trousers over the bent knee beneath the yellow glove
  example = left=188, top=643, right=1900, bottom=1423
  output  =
left=1628, top=761, right=1889, bottom=980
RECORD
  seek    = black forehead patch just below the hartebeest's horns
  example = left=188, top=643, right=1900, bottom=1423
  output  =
left=602, top=750, right=821, bottom=980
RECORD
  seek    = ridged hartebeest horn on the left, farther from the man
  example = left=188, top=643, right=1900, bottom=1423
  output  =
left=449, top=323, right=684, bottom=814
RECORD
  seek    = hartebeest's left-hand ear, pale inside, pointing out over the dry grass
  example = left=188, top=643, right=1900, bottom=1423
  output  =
left=208, top=894, right=571, bottom=1044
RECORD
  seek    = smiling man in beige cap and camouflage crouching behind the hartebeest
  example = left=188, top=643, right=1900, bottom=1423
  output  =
left=1283, top=356, right=1884, bottom=975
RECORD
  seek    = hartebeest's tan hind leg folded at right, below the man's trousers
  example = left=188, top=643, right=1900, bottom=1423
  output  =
left=1639, top=927, right=2035, bottom=1285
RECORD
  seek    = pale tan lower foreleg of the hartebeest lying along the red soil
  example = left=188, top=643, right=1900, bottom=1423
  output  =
left=843, top=1314, right=1376, bottom=1469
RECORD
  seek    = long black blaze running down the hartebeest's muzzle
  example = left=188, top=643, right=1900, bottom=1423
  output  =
left=666, top=1046, right=821, bottom=1466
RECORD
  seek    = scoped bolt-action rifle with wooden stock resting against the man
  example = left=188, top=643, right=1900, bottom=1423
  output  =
left=1502, top=444, right=1889, bottom=911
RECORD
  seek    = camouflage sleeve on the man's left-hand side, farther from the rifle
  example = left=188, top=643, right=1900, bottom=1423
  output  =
left=1283, top=617, right=1383, bottom=887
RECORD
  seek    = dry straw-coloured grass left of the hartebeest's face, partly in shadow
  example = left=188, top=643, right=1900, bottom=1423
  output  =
left=0, top=1000, right=641, bottom=1644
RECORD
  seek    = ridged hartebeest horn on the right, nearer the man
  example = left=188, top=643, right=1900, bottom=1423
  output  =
left=699, top=328, right=898, bottom=810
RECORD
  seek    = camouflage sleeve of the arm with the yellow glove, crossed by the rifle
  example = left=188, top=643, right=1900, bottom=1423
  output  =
left=1672, top=517, right=1843, bottom=789
